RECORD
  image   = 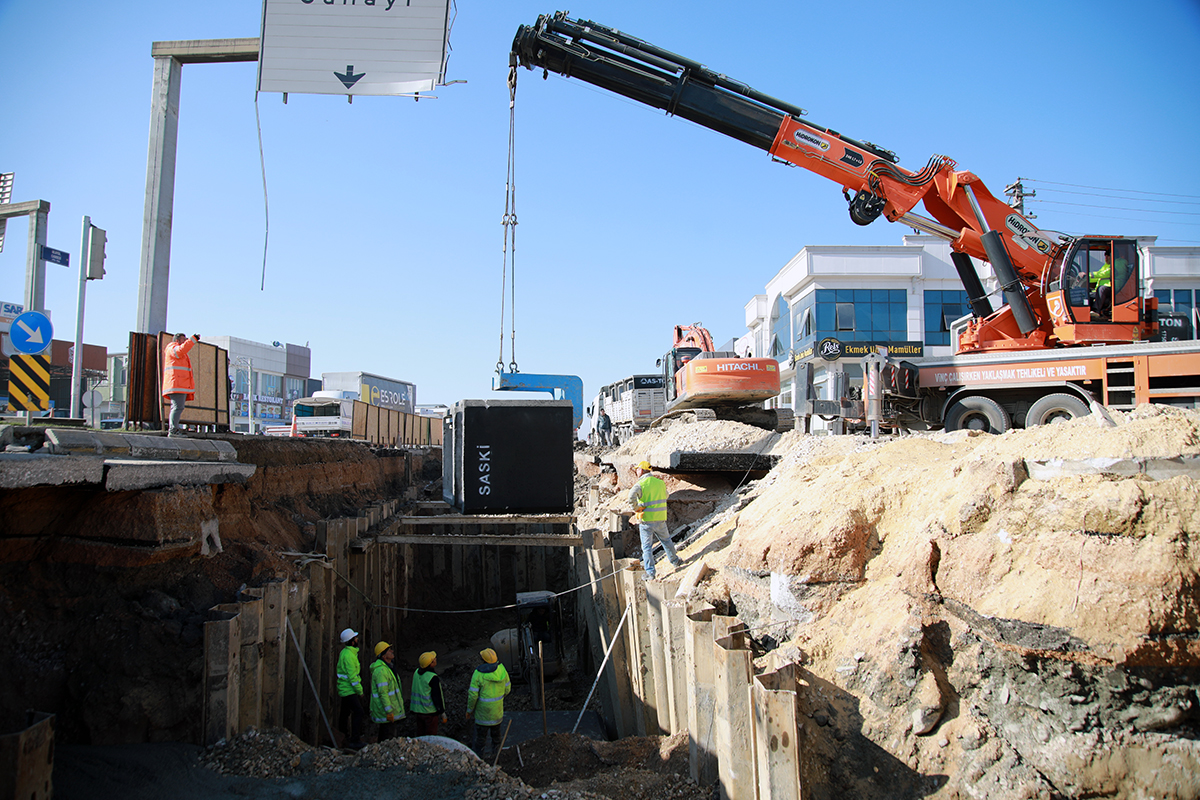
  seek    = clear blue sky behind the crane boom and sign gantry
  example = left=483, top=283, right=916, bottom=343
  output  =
left=0, top=0, right=1200, bottom=404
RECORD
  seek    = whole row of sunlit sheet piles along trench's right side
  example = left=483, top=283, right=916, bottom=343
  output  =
left=574, top=531, right=804, bottom=800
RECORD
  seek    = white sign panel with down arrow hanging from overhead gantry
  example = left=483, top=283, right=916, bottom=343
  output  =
left=258, top=0, right=450, bottom=95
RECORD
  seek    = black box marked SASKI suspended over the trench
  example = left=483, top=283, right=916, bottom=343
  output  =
left=442, top=399, right=575, bottom=513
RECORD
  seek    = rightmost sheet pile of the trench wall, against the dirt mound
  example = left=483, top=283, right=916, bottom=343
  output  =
left=750, top=664, right=800, bottom=800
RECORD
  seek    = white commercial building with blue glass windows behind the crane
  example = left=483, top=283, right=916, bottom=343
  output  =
left=737, top=235, right=1200, bottom=431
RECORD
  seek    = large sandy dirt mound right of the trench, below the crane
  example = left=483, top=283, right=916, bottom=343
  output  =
left=662, top=407, right=1200, bottom=798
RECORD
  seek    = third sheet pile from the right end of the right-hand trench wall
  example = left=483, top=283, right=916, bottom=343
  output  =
left=684, top=603, right=719, bottom=786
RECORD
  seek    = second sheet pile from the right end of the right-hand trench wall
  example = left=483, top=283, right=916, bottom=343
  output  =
left=713, top=618, right=757, bottom=800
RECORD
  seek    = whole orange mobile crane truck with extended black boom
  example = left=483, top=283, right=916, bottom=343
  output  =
left=510, top=12, right=1200, bottom=431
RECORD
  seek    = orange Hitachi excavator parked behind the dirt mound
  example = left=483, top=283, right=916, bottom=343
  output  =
left=659, top=323, right=794, bottom=431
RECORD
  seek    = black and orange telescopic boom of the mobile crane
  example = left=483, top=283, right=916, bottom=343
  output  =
left=510, top=12, right=1104, bottom=349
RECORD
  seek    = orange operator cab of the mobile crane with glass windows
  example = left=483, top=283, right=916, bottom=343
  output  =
left=1044, top=237, right=1158, bottom=344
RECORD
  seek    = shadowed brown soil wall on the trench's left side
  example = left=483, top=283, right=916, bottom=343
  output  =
left=0, top=437, right=440, bottom=744
